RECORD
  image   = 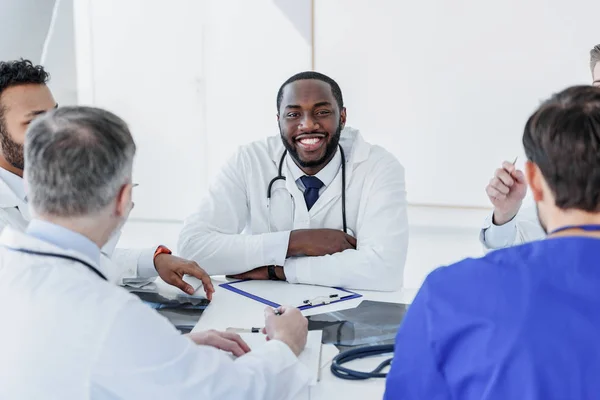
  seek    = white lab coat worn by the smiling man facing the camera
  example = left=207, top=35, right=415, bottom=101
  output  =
left=179, top=128, right=408, bottom=290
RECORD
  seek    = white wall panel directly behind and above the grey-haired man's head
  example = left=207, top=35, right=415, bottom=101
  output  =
left=75, top=0, right=207, bottom=220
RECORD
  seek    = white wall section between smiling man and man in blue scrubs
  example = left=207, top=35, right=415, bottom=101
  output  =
left=315, top=0, right=600, bottom=206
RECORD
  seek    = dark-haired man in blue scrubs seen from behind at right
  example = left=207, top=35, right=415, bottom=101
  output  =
left=385, top=86, right=600, bottom=400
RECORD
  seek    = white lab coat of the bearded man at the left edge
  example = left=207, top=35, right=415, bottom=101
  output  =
left=0, top=173, right=146, bottom=284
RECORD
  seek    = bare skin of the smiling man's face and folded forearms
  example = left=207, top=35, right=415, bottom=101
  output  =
left=231, top=79, right=356, bottom=280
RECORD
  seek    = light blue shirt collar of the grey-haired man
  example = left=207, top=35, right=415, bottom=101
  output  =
left=26, top=219, right=100, bottom=265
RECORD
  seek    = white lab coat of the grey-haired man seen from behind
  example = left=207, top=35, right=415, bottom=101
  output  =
left=0, top=228, right=310, bottom=400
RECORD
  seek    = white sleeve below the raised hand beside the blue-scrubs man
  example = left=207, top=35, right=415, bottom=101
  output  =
left=479, top=202, right=546, bottom=250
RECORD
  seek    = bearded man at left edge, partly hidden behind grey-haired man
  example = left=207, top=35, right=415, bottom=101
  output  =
left=0, top=60, right=209, bottom=294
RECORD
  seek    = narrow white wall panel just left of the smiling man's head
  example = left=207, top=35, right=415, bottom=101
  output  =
left=204, top=0, right=311, bottom=177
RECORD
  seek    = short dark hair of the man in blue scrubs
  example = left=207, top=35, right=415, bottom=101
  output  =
left=523, top=86, right=600, bottom=212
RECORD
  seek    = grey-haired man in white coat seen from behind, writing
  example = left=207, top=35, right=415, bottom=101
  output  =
left=0, top=107, right=310, bottom=400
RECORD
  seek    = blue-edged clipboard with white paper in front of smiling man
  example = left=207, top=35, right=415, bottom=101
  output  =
left=219, top=279, right=362, bottom=311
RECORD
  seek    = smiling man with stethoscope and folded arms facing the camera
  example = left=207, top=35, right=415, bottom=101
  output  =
left=178, top=72, right=408, bottom=290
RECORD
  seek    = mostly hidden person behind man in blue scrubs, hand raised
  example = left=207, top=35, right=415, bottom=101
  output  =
left=479, top=44, right=600, bottom=250
